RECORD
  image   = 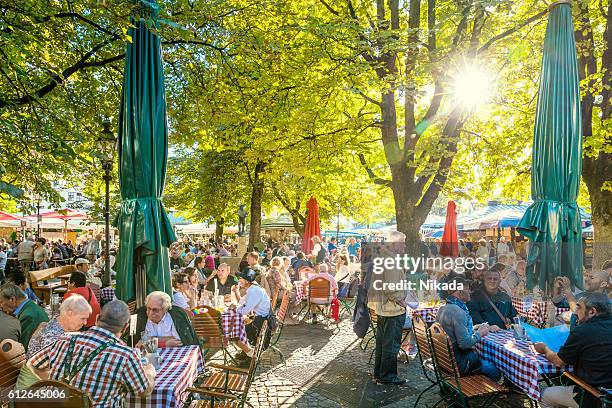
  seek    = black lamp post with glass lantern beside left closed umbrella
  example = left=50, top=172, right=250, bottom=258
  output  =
left=94, top=119, right=117, bottom=287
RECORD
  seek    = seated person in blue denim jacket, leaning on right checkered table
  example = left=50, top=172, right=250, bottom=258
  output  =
left=436, top=276, right=501, bottom=381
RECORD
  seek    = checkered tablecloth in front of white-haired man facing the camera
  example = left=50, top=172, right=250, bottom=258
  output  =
left=125, top=346, right=204, bottom=408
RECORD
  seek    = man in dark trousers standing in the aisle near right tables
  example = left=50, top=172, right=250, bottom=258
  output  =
left=368, top=232, right=406, bottom=385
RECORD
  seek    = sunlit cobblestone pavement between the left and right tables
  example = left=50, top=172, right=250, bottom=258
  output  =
left=238, top=319, right=530, bottom=408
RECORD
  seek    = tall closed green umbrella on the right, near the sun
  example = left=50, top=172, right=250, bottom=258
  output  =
left=518, top=1, right=582, bottom=293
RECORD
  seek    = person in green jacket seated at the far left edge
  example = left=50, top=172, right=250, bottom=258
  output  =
left=0, top=283, right=49, bottom=351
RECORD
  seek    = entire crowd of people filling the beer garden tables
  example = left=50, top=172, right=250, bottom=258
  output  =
left=0, top=232, right=612, bottom=407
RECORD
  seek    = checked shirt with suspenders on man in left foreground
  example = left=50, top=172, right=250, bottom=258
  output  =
left=32, top=326, right=148, bottom=408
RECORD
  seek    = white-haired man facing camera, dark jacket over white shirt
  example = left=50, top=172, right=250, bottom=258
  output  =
left=134, top=291, right=200, bottom=347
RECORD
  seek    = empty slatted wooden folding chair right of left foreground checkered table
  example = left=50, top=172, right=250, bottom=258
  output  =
left=187, top=320, right=268, bottom=408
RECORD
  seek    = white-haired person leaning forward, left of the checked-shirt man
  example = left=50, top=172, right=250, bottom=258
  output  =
left=16, top=294, right=91, bottom=390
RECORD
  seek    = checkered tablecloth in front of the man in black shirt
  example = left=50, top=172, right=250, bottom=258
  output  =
left=476, top=330, right=564, bottom=400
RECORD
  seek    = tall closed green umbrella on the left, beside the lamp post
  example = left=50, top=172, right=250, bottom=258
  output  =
left=115, top=0, right=176, bottom=302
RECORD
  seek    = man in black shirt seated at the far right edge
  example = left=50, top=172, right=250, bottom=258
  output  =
left=534, top=292, right=612, bottom=408
